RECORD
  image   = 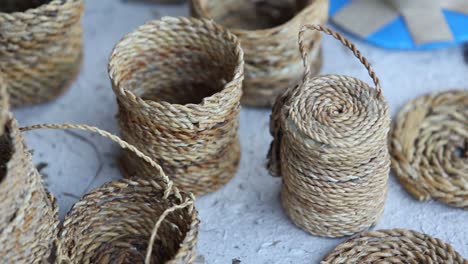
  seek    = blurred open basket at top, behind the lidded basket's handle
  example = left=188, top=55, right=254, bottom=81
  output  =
left=191, top=0, right=329, bottom=107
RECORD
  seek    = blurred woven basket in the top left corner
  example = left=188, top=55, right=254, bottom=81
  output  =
left=0, top=0, right=84, bottom=106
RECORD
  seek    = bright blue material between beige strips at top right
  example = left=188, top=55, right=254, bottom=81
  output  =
left=330, top=0, right=468, bottom=50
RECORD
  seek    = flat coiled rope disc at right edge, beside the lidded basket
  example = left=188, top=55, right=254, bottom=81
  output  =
left=390, top=90, right=468, bottom=209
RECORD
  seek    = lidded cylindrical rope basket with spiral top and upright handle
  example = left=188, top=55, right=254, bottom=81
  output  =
left=268, top=25, right=390, bottom=237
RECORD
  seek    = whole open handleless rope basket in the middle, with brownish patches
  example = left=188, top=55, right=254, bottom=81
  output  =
left=109, top=17, right=244, bottom=194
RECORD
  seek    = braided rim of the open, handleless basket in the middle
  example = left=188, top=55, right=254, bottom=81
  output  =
left=108, top=16, right=245, bottom=111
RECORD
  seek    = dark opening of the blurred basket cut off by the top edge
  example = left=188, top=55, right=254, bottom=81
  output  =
left=200, top=0, right=315, bottom=30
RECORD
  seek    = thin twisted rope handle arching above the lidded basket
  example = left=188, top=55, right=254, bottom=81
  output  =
left=299, top=24, right=382, bottom=96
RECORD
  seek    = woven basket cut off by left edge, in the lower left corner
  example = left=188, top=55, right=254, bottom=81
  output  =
left=0, top=80, right=59, bottom=263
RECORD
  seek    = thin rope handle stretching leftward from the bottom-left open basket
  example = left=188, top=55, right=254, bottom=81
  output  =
left=20, top=124, right=173, bottom=198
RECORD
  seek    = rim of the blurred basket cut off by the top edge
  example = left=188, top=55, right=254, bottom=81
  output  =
left=191, top=0, right=328, bottom=36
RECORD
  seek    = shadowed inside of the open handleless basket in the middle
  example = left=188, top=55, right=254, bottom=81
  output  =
left=111, top=22, right=238, bottom=105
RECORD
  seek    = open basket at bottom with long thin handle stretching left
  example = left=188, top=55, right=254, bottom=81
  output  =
left=22, top=124, right=199, bottom=264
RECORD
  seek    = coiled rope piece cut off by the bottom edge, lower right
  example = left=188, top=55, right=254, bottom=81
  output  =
left=321, top=229, right=468, bottom=264
